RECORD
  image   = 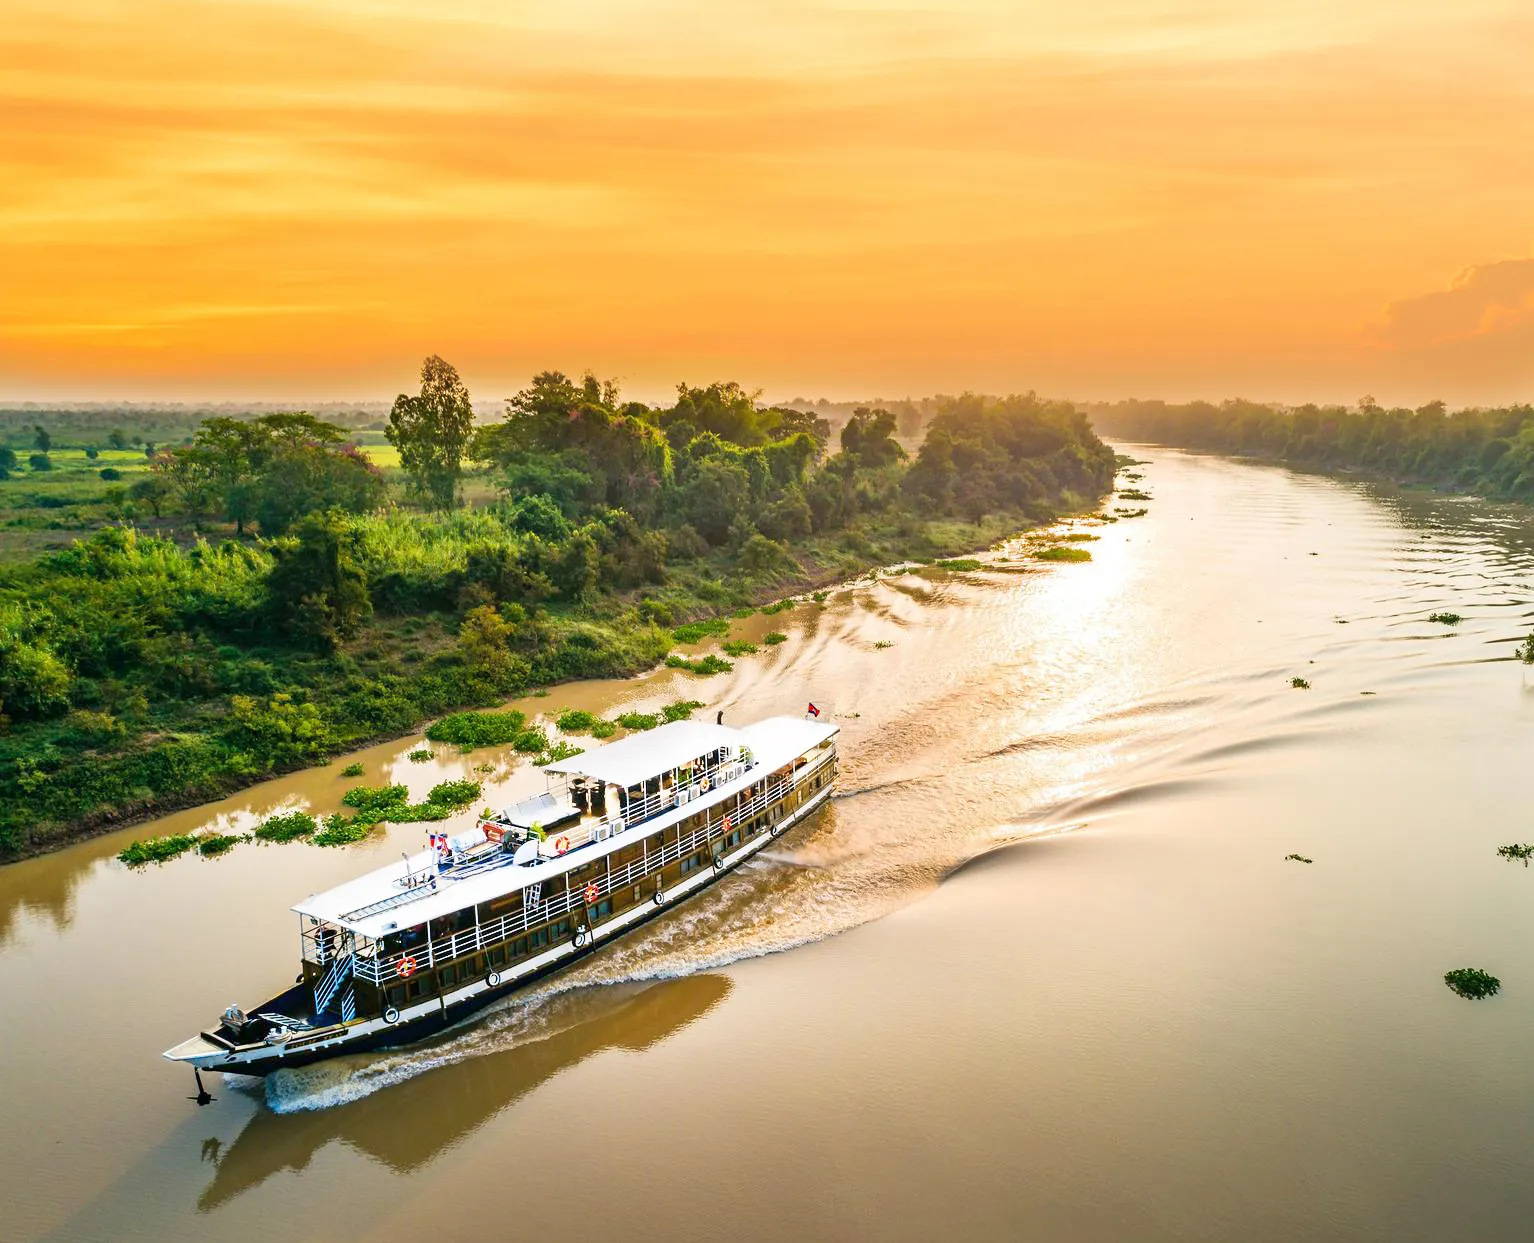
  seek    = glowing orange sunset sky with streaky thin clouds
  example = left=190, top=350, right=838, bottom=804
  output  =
left=0, top=0, right=1534, bottom=404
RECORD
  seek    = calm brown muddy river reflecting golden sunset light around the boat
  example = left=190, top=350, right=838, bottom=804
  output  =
left=0, top=451, right=1534, bottom=1243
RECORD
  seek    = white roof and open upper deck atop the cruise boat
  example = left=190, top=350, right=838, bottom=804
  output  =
left=293, top=717, right=838, bottom=939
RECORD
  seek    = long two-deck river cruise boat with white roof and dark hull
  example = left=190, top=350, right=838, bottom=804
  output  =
left=164, top=709, right=838, bottom=1080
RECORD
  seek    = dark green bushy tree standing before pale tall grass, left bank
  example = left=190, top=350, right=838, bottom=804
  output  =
left=267, top=509, right=373, bottom=652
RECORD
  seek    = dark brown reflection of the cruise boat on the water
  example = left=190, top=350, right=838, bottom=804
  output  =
left=198, top=974, right=730, bottom=1212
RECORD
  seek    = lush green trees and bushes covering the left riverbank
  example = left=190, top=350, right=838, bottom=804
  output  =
left=0, top=359, right=1115, bottom=855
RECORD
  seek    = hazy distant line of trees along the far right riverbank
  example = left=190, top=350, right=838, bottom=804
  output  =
left=1091, top=397, right=1534, bottom=502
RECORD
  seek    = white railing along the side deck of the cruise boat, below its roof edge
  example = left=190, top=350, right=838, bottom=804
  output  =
left=353, top=752, right=836, bottom=985
